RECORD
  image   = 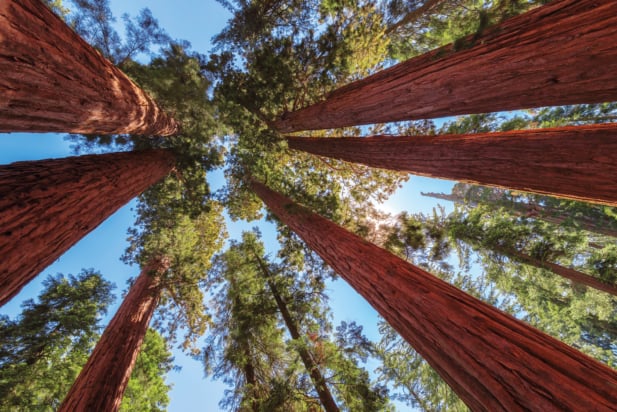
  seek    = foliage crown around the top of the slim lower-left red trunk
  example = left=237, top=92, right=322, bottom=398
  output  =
left=124, top=200, right=227, bottom=352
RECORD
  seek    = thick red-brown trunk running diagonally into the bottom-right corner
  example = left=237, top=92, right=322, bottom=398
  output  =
left=252, top=181, right=617, bottom=411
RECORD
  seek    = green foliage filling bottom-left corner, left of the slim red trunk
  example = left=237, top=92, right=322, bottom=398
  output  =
left=0, top=270, right=113, bottom=411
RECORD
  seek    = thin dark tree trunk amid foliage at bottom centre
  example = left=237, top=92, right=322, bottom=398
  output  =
left=255, top=254, right=339, bottom=412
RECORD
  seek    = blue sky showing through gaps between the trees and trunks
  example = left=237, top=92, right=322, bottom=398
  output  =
left=0, top=0, right=452, bottom=412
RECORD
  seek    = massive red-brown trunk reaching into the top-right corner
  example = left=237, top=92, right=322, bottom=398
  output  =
left=273, top=0, right=617, bottom=132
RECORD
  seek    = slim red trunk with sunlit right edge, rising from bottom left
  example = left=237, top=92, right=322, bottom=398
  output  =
left=59, top=258, right=169, bottom=412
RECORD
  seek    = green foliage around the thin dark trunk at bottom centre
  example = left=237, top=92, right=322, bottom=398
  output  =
left=205, top=232, right=387, bottom=411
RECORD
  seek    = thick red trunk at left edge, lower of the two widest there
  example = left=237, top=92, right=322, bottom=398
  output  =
left=0, top=150, right=175, bottom=305
